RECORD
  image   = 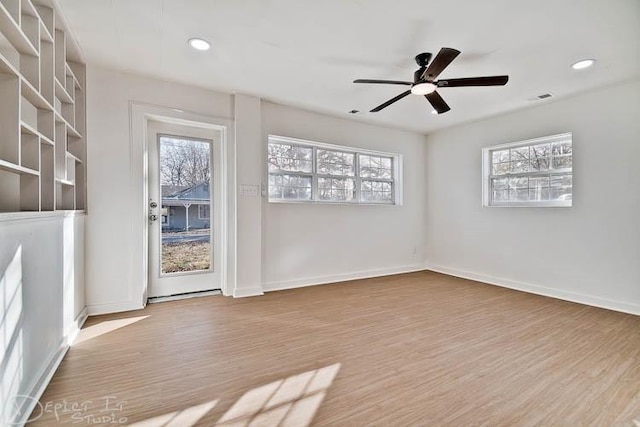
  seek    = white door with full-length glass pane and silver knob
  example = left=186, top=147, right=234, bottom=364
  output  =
left=148, top=121, right=223, bottom=298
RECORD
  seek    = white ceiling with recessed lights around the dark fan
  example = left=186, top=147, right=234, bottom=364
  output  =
left=60, top=0, right=640, bottom=132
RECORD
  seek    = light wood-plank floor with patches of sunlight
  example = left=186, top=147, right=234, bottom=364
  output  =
left=30, top=272, right=640, bottom=427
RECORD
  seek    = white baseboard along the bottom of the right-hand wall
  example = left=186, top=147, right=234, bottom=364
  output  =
left=425, top=263, right=640, bottom=316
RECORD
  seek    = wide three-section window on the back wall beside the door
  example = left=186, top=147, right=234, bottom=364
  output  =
left=267, top=135, right=401, bottom=204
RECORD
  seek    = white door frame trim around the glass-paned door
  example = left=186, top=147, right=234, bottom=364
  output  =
left=129, top=101, right=236, bottom=307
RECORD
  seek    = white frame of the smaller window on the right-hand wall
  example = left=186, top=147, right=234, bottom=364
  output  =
left=482, top=132, right=574, bottom=208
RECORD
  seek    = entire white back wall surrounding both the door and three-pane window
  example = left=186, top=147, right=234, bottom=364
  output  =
left=82, top=66, right=425, bottom=308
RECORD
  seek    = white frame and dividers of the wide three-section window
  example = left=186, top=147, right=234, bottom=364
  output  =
left=264, top=135, right=403, bottom=206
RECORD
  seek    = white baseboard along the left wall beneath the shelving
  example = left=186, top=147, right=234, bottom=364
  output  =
left=11, top=307, right=87, bottom=425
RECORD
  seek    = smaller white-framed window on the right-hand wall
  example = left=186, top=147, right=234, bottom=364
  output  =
left=482, top=133, right=573, bottom=206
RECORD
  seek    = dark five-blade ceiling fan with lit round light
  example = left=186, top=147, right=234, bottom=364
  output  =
left=353, top=47, right=509, bottom=114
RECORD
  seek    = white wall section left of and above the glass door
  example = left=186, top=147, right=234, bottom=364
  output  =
left=87, top=66, right=234, bottom=314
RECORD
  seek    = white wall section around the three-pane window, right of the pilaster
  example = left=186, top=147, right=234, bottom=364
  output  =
left=262, top=102, right=429, bottom=290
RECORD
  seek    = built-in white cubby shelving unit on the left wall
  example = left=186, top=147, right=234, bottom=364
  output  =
left=0, top=0, right=87, bottom=212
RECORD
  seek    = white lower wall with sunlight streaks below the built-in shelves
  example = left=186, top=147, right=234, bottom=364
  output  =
left=0, top=212, right=86, bottom=425
